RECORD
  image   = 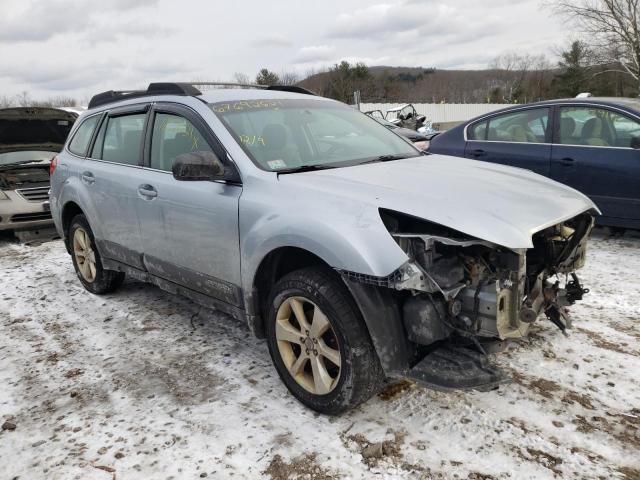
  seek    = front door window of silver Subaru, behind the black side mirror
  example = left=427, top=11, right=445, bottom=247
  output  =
left=151, top=113, right=213, bottom=172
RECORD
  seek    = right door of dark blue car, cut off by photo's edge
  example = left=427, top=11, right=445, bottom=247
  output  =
left=551, top=104, right=640, bottom=225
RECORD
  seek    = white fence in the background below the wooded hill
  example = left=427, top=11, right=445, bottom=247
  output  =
left=360, top=103, right=509, bottom=123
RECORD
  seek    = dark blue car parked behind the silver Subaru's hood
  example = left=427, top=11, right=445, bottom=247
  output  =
left=429, top=97, right=640, bottom=228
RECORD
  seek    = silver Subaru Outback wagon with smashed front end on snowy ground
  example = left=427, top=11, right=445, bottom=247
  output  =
left=50, top=83, right=598, bottom=414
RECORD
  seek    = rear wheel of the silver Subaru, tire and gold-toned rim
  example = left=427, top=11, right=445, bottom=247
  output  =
left=67, top=214, right=124, bottom=295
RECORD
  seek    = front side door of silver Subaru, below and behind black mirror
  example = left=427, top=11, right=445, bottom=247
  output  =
left=137, top=103, right=242, bottom=305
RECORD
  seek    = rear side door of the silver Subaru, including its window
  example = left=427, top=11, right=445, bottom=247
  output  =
left=80, top=104, right=149, bottom=268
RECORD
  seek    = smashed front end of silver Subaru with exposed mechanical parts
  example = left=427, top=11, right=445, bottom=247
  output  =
left=344, top=210, right=593, bottom=390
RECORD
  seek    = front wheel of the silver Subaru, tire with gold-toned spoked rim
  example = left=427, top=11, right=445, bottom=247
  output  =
left=266, top=267, right=384, bottom=415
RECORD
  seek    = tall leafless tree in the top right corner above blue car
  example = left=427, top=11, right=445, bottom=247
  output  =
left=550, top=0, right=640, bottom=89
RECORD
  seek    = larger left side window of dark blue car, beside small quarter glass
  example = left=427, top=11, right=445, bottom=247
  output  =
left=487, top=108, right=549, bottom=143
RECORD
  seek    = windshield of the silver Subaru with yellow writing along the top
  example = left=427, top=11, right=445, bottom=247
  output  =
left=210, top=99, right=420, bottom=171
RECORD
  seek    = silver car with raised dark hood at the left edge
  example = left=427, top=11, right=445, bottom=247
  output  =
left=0, top=107, right=78, bottom=236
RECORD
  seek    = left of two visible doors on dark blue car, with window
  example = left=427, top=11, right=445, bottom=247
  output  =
left=464, top=107, right=551, bottom=176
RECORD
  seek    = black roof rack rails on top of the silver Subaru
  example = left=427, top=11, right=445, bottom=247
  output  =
left=89, top=82, right=315, bottom=109
